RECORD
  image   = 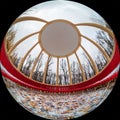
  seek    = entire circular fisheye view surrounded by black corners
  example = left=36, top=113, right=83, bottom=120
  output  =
left=0, top=0, right=120, bottom=120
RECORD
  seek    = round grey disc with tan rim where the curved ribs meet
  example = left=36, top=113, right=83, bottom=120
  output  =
left=40, top=20, right=80, bottom=57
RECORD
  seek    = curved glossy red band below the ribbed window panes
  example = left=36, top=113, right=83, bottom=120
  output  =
left=1, top=39, right=120, bottom=92
